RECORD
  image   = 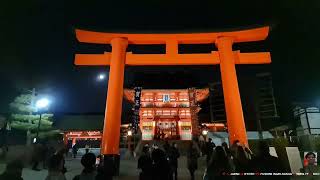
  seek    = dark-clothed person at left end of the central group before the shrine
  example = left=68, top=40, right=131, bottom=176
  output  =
left=138, top=146, right=152, bottom=180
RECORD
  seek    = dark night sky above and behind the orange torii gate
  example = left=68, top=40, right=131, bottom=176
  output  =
left=0, top=0, right=320, bottom=125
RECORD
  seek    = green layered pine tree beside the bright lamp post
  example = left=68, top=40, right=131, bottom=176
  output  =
left=9, top=93, right=53, bottom=131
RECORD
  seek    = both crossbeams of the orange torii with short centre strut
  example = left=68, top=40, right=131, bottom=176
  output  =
left=75, top=27, right=271, bottom=66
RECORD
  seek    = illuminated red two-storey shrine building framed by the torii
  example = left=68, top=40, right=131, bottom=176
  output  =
left=124, top=88, right=209, bottom=140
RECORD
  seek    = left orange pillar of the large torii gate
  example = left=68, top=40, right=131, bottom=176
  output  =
left=101, top=38, right=128, bottom=156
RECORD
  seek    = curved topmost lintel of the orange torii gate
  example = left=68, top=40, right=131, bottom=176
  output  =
left=76, top=26, right=269, bottom=44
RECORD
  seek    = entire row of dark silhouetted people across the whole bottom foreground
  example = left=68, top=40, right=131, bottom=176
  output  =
left=0, top=138, right=319, bottom=180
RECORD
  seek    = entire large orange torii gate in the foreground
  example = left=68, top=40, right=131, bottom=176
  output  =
left=75, top=27, right=271, bottom=155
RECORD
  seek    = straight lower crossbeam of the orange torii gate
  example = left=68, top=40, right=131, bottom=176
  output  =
left=75, top=51, right=271, bottom=66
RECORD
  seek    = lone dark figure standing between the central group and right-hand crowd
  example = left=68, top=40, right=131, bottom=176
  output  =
left=187, top=142, right=199, bottom=180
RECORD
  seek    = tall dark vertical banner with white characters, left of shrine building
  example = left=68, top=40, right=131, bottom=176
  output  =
left=132, top=87, right=142, bottom=133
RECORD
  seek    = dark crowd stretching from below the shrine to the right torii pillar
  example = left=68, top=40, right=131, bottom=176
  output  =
left=138, top=138, right=292, bottom=180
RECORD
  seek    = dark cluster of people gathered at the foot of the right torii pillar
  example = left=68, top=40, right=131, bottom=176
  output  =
left=204, top=138, right=286, bottom=180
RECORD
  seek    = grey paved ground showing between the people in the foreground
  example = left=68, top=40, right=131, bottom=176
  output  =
left=0, top=157, right=205, bottom=180
